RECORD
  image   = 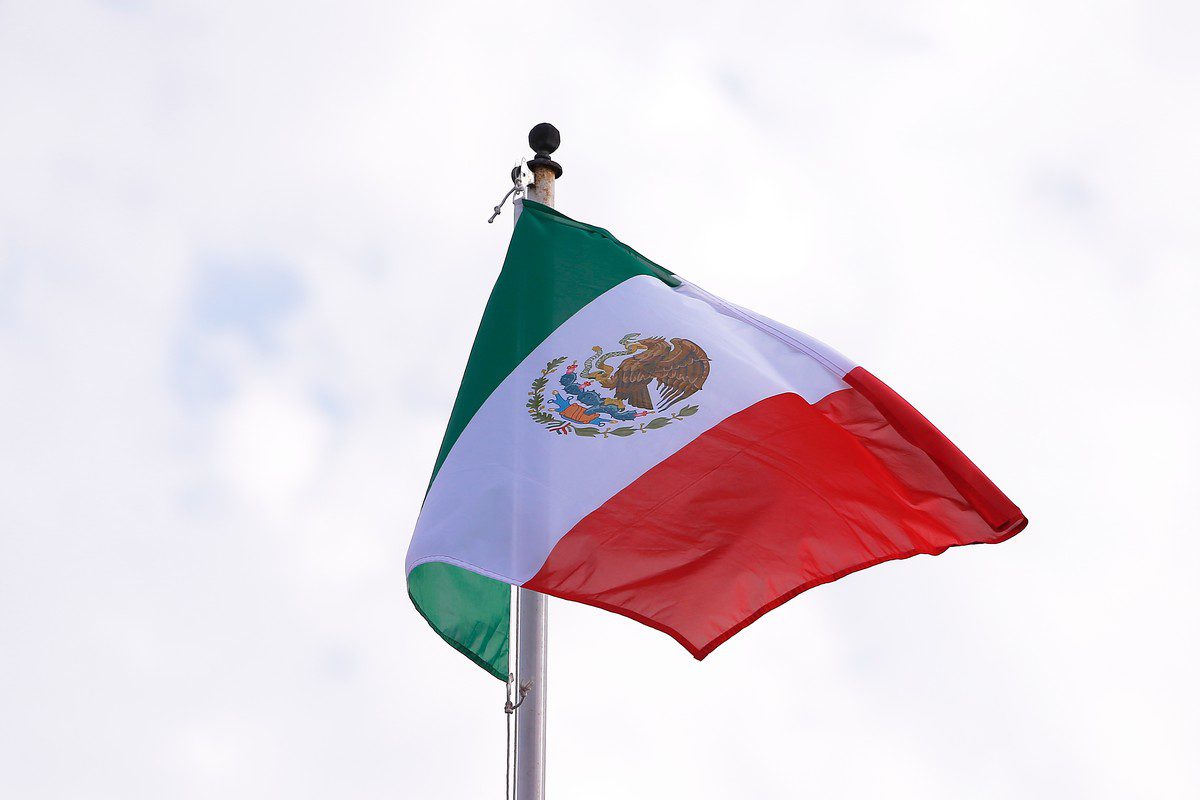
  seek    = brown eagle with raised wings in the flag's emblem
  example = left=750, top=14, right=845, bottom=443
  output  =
left=612, top=336, right=709, bottom=411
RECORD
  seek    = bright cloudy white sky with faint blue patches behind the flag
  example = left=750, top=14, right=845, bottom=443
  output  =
left=0, top=0, right=1200, bottom=800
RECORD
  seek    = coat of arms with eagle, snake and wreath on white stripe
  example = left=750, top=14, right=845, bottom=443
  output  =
left=526, top=333, right=709, bottom=439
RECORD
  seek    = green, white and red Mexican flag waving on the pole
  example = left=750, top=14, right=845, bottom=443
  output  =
left=406, top=200, right=1026, bottom=680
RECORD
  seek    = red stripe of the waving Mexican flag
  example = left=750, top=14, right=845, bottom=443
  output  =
left=524, top=379, right=1026, bottom=658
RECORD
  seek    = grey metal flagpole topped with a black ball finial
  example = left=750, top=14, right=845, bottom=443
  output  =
left=512, top=122, right=563, bottom=800
